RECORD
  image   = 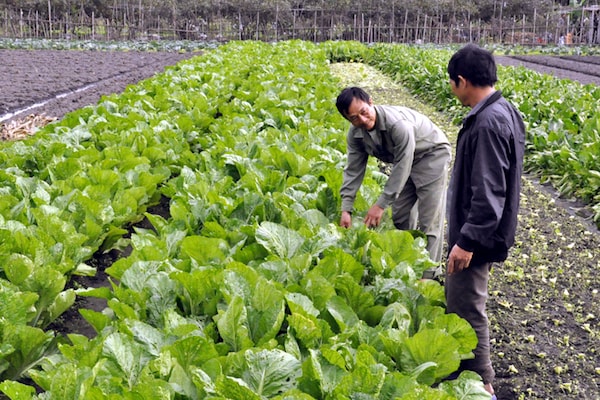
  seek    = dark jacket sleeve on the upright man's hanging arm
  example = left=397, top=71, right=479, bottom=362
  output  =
left=457, top=124, right=510, bottom=251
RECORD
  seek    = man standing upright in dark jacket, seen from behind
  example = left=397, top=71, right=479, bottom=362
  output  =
left=445, top=45, right=525, bottom=398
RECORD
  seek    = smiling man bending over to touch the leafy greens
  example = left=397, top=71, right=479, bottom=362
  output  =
left=336, top=87, right=451, bottom=272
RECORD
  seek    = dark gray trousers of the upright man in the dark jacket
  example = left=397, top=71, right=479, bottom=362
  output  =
left=444, top=263, right=495, bottom=384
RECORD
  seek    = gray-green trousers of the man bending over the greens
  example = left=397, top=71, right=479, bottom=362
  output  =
left=392, top=173, right=448, bottom=263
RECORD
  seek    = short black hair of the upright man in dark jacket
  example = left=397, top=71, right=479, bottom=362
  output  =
left=448, top=44, right=498, bottom=87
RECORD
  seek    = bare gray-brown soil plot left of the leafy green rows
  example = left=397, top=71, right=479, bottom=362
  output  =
left=0, top=50, right=196, bottom=123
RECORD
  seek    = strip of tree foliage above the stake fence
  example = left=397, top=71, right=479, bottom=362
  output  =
left=0, top=0, right=590, bottom=20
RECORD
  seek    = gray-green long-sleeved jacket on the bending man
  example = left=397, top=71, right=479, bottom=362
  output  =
left=340, top=106, right=451, bottom=212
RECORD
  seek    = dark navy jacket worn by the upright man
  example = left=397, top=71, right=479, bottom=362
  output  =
left=448, top=91, right=525, bottom=263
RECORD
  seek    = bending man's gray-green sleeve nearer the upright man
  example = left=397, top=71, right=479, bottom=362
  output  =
left=375, top=121, right=416, bottom=209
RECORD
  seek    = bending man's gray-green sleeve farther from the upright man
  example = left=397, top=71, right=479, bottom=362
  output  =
left=340, top=134, right=369, bottom=212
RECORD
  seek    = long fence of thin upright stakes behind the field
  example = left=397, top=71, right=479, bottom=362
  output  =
left=0, top=6, right=600, bottom=45
